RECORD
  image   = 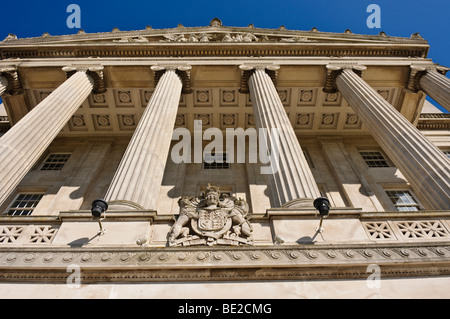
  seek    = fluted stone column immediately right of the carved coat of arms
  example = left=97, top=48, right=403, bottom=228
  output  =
left=241, top=66, right=320, bottom=208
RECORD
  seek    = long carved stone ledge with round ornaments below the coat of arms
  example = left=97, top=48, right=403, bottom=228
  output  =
left=0, top=242, right=450, bottom=282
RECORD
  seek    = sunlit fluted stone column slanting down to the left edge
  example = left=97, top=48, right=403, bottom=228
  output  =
left=0, top=70, right=94, bottom=208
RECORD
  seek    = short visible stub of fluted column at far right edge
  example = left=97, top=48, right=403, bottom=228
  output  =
left=419, top=68, right=450, bottom=112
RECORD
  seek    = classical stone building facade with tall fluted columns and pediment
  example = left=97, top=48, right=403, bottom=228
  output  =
left=0, top=19, right=450, bottom=298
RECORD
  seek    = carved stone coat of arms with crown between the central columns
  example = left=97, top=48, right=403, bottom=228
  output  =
left=168, top=184, right=253, bottom=246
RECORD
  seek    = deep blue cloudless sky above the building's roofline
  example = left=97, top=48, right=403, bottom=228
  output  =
left=0, top=0, right=450, bottom=111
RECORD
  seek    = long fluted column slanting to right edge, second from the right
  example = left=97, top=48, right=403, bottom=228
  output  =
left=336, top=67, right=450, bottom=210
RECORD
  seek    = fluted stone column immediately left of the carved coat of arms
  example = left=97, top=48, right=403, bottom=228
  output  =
left=105, top=69, right=182, bottom=209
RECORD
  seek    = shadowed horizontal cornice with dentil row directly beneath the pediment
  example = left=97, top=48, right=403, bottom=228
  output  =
left=0, top=43, right=428, bottom=59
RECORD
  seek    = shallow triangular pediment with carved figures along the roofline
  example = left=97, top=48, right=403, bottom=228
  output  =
left=0, top=18, right=427, bottom=46
